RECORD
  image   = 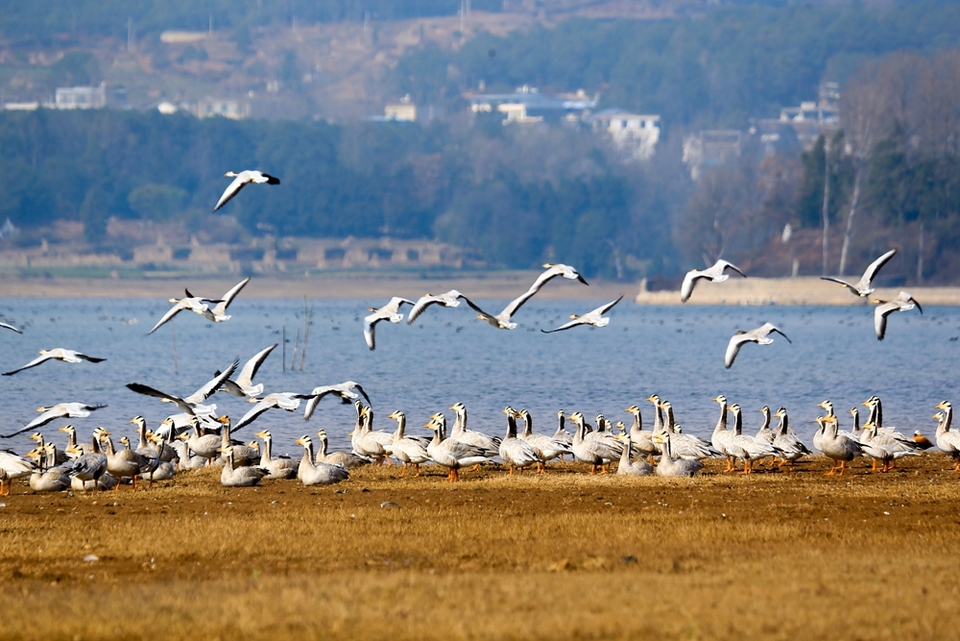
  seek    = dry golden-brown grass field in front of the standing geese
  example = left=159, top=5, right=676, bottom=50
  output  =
left=0, top=454, right=960, bottom=639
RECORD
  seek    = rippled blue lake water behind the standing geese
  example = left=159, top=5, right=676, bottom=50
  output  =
left=0, top=296, right=960, bottom=453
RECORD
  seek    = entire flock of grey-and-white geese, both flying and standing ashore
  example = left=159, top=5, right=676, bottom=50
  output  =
left=0, top=170, right=936, bottom=494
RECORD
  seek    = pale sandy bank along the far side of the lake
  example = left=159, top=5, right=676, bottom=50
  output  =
left=0, top=271, right=960, bottom=306
